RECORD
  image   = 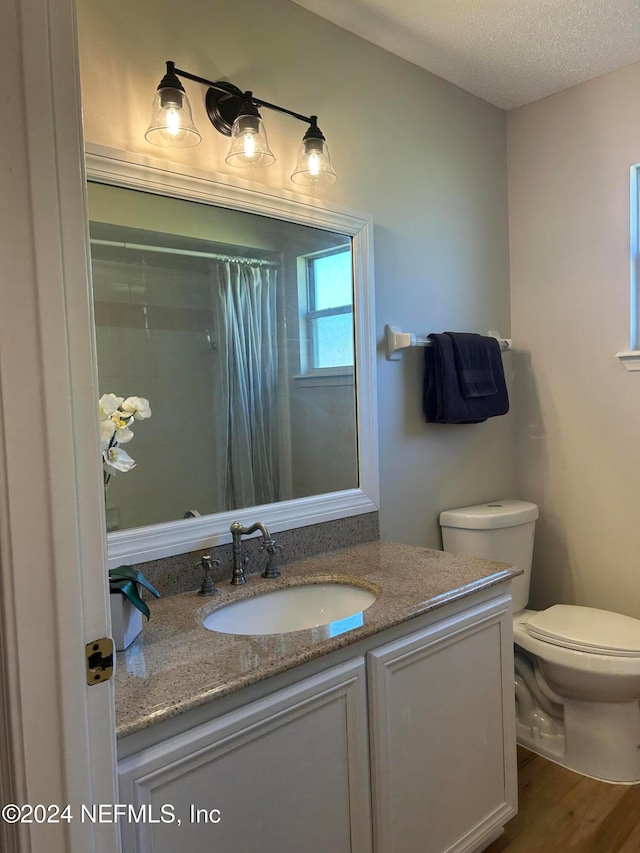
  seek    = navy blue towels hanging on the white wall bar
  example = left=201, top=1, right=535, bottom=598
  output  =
left=423, top=332, right=509, bottom=424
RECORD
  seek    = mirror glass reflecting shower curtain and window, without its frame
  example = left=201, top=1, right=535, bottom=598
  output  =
left=89, top=182, right=358, bottom=530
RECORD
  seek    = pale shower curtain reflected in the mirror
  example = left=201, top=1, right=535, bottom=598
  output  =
left=212, top=260, right=279, bottom=509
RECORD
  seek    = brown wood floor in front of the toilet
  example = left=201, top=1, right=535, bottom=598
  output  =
left=485, top=747, right=640, bottom=853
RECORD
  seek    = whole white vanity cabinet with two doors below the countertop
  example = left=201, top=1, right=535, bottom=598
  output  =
left=119, top=587, right=517, bottom=853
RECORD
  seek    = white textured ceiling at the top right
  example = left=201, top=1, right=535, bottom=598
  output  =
left=294, top=0, right=640, bottom=109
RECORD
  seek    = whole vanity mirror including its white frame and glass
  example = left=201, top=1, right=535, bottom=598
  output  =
left=86, top=146, right=378, bottom=566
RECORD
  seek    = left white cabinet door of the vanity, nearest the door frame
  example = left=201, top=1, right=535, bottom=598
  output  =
left=120, top=660, right=371, bottom=853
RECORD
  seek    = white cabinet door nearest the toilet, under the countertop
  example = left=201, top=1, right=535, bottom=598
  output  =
left=370, top=598, right=516, bottom=853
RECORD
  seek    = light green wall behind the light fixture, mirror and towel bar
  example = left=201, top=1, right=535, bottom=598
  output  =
left=78, top=0, right=513, bottom=546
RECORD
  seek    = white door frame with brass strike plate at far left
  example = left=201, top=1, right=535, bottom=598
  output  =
left=0, top=0, right=119, bottom=853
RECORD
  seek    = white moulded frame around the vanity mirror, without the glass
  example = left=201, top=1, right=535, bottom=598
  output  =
left=86, top=144, right=379, bottom=568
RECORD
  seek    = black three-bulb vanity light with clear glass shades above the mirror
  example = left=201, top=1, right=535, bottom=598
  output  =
left=145, top=62, right=336, bottom=186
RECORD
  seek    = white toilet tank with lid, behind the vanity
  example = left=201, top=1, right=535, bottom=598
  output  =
left=440, top=500, right=539, bottom=613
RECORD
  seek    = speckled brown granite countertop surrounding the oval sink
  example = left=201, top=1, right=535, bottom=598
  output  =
left=115, top=540, right=520, bottom=737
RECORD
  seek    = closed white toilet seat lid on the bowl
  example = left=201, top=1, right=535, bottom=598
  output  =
left=522, top=604, right=640, bottom=658
